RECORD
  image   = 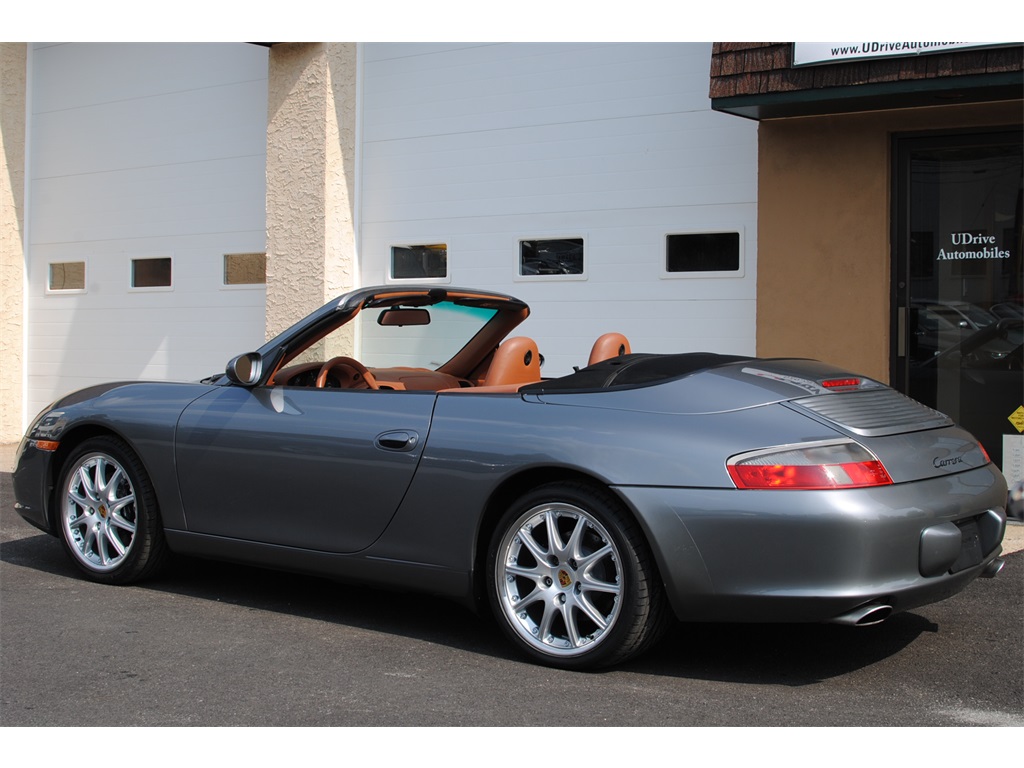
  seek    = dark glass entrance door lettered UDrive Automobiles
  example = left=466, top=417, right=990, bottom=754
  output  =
left=891, top=131, right=1024, bottom=482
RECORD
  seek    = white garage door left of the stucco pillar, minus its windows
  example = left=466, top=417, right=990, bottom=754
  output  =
left=27, top=43, right=267, bottom=417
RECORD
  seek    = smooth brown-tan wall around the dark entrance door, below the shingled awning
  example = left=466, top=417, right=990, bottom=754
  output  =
left=757, top=101, right=1022, bottom=381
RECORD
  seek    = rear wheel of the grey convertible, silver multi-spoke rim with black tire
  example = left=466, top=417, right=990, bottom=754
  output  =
left=487, top=483, right=668, bottom=670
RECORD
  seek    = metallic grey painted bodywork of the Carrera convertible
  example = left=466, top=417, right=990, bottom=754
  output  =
left=15, top=290, right=1006, bottom=621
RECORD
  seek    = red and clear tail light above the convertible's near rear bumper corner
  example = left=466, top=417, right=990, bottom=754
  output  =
left=726, top=440, right=893, bottom=490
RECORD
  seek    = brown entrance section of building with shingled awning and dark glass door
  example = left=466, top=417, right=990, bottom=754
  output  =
left=711, top=43, right=1024, bottom=481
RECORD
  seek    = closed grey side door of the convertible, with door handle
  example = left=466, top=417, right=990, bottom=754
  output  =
left=175, top=386, right=435, bottom=553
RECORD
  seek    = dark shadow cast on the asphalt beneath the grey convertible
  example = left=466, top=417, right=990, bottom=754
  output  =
left=0, top=535, right=958, bottom=686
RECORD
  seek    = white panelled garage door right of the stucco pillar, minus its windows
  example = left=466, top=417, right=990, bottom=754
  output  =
left=359, top=43, right=757, bottom=375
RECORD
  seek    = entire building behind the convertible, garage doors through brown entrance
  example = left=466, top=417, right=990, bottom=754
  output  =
left=0, top=43, right=1024, bottom=480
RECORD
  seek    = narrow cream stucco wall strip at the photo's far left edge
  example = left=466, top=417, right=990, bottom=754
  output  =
left=0, top=43, right=28, bottom=443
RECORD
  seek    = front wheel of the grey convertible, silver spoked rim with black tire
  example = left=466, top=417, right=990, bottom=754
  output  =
left=56, top=437, right=169, bottom=584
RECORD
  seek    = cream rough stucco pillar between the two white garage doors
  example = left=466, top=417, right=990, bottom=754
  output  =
left=266, top=43, right=357, bottom=353
